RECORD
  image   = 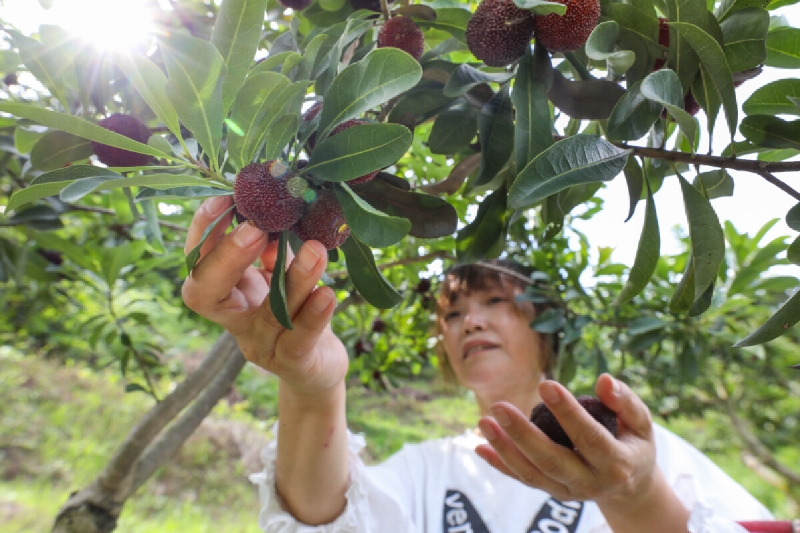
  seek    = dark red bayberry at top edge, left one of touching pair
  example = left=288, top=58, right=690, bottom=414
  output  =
left=466, top=0, right=534, bottom=67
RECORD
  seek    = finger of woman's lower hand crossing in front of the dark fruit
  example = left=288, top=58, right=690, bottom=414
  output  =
left=539, top=380, right=618, bottom=464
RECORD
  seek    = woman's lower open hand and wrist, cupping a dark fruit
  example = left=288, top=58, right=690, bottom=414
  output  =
left=476, top=374, right=689, bottom=532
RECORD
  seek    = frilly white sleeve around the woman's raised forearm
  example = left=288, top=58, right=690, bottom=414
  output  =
left=250, top=424, right=414, bottom=533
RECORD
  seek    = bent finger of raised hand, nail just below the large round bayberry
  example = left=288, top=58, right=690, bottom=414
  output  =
left=183, top=224, right=266, bottom=321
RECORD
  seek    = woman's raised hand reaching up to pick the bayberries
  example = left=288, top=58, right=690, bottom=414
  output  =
left=183, top=196, right=348, bottom=394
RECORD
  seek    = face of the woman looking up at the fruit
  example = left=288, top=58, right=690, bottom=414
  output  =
left=439, top=285, right=542, bottom=394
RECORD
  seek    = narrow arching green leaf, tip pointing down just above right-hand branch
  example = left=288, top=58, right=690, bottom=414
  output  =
left=670, top=22, right=739, bottom=137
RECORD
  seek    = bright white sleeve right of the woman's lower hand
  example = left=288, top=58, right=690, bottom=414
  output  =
left=653, top=424, right=774, bottom=533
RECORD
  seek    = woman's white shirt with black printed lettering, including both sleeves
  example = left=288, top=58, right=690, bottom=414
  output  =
left=250, top=425, right=772, bottom=533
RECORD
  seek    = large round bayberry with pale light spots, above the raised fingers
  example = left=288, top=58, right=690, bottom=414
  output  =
left=233, top=161, right=308, bottom=233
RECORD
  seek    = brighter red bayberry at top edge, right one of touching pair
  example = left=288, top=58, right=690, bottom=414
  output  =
left=533, top=0, right=600, bottom=52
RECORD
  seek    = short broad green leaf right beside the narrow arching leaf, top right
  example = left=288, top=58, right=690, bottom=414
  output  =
left=720, top=7, right=769, bottom=72
